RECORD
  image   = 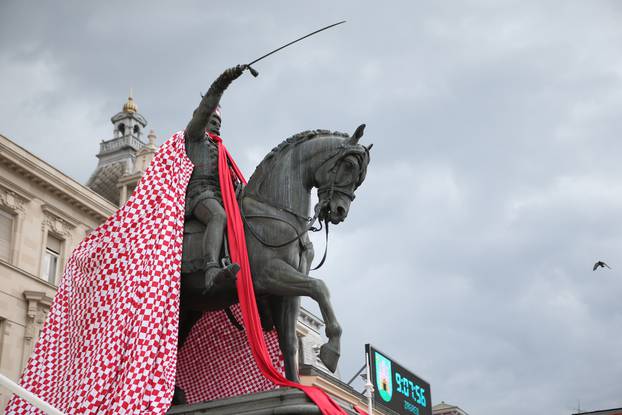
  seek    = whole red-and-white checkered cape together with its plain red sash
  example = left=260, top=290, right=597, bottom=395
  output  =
left=6, top=132, right=344, bottom=415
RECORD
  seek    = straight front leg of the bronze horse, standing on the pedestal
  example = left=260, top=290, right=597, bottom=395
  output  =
left=273, top=297, right=300, bottom=382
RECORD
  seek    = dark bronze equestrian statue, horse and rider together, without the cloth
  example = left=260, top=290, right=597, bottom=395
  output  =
left=178, top=65, right=371, bottom=400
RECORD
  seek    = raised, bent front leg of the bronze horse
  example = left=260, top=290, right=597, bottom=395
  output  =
left=254, top=259, right=341, bottom=372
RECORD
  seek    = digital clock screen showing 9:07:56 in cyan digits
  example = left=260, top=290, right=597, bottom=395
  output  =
left=365, top=344, right=432, bottom=415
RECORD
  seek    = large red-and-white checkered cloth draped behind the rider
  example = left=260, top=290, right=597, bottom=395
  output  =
left=6, top=133, right=193, bottom=414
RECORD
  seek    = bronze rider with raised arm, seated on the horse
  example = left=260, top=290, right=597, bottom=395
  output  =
left=185, top=65, right=246, bottom=292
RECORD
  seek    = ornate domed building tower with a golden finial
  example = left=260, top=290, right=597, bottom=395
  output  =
left=86, top=92, right=147, bottom=206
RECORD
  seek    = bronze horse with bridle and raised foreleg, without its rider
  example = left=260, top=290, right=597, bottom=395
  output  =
left=178, top=125, right=371, bottom=390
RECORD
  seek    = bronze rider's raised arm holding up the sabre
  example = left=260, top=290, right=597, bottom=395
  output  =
left=186, top=65, right=246, bottom=141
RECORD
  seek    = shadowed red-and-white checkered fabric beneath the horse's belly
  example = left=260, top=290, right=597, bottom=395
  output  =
left=177, top=305, right=284, bottom=403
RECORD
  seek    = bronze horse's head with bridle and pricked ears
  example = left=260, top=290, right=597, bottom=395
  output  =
left=315, top=124, right=372, bottom=224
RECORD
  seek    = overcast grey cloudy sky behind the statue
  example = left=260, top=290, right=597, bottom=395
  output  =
left=0, top=0, right=622, bottom=415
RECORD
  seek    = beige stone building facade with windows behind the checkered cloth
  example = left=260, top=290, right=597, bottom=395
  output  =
left=0, top=135, right=116, bottom=411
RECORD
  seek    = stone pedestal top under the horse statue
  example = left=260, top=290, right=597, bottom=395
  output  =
left=167, top=388, right=357, bottom=415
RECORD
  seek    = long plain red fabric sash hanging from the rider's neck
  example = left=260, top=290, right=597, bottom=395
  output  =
left=210, top=134, right=347, bottom=415
